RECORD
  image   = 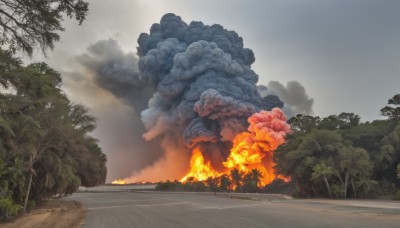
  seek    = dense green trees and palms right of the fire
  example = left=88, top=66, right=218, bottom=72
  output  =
left=274, top=94, right=400, bottom=199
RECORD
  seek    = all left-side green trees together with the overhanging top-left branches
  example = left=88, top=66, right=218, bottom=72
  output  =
left=0, top=0, right=107, bottom=221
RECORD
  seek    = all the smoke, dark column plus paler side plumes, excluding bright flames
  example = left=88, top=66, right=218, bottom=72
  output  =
left=65, top=14, right=312, bottom=182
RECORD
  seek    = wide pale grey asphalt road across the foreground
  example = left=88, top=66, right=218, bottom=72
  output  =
left=68, top=191, right=400, bottom=228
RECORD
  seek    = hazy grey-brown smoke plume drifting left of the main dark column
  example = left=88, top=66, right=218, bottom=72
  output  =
left=64, top=39, right=164, bottom=181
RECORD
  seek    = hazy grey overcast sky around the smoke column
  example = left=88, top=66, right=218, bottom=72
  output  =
left=26, top=0, right=400, bottom=181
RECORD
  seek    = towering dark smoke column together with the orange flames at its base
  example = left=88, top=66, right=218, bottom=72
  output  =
left=113, top=14, right=290, bottom=185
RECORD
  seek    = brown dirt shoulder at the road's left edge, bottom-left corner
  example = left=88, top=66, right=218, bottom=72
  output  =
left=0, top=199, right=86, bottom=228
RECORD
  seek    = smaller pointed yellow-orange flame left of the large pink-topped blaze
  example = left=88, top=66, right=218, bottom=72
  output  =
left=181, top=147, right=221, bottom=182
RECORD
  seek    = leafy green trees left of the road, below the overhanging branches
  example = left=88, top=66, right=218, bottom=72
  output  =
left=0, top=50, right=107, bottom=219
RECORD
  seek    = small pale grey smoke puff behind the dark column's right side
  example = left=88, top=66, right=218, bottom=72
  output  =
left=258, top=81, right=314, bottom=118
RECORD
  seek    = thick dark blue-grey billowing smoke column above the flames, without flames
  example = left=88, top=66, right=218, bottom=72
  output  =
left=138, top=14, right=262, bottom=166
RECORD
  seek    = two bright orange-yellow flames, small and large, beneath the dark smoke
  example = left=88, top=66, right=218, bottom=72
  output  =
left=181, top=108, right=290, bottom=185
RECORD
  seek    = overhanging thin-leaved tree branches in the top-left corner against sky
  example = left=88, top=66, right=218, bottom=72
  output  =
left=0, top=0, right=89, bottom=55
